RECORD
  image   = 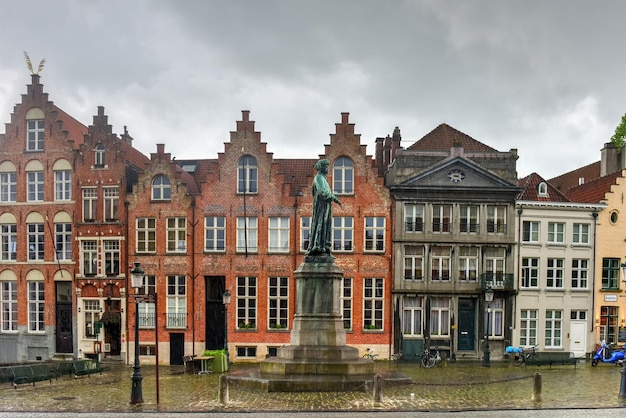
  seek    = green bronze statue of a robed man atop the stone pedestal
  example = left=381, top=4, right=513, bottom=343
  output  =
left=306, top=159, right=341, bottom=256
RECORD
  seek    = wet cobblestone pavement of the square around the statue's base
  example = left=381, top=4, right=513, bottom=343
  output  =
left=0, top=361, right=626, bottom=412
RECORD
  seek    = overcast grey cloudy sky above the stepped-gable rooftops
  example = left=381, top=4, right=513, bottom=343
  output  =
left=0, top=0, right=626, bottom=178
